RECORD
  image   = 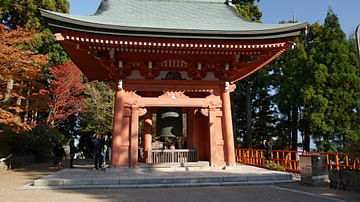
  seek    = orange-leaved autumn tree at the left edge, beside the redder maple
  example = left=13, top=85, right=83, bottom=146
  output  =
left=0, top=25, right=47, bottom=132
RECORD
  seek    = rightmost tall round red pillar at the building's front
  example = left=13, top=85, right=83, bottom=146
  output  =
left=221, top=87, right=236, bottom=166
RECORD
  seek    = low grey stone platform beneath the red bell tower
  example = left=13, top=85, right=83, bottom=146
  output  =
left=30, top=164, right=293, bottom=189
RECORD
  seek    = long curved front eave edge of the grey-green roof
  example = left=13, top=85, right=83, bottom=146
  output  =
left=40, top=9, right=308, bottom=40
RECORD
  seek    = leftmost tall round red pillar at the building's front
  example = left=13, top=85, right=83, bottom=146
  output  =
left=111, top=90, right=125, bottom=167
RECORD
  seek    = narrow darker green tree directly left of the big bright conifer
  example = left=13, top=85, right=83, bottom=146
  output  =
left=267, top=39, right=310, bottom=151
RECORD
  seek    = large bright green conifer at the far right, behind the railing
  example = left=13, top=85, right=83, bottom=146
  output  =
left=304, top=8, right=360, bottom=151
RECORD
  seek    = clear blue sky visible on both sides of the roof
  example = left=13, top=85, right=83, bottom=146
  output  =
left=69, top=0, right=360, bottom=36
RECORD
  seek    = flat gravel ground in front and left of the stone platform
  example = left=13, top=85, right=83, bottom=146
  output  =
left=0, top=162, right=360, bottom=202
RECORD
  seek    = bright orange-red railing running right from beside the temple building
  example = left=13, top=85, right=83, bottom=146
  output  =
left=235, top=148, right=360, bottom=172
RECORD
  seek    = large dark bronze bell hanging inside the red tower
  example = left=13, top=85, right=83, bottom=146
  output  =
left=156, top=107, right=183, bottom=137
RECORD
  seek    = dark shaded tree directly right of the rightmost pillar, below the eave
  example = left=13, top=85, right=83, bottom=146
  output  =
left=232, top=68, right=275, bottom=148
